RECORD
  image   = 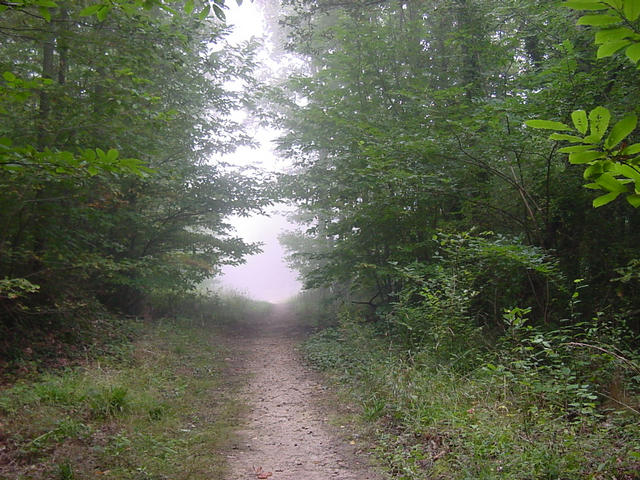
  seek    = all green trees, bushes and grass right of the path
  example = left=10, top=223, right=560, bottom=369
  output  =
left=273, top=0, right=640, bottom=479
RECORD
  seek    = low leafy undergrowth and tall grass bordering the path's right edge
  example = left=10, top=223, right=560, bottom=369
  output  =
left=305, top=310, right=640, bottom=480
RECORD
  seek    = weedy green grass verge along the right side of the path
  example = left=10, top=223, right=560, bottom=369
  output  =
left=304, top=317, right=640, bottom=480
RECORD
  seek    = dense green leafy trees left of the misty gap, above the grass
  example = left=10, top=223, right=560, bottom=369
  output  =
left=0, top=0, right=269, bottom=356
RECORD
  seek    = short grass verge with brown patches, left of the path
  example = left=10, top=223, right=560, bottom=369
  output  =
left=0, top=321, right=238, bottom=480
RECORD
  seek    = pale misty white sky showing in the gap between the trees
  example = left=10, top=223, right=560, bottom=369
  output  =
left=216, top=2, right=301, bottom=303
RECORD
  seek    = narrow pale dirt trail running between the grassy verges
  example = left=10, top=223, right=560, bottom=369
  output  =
left=225, top=306, right=382, bottom=480
